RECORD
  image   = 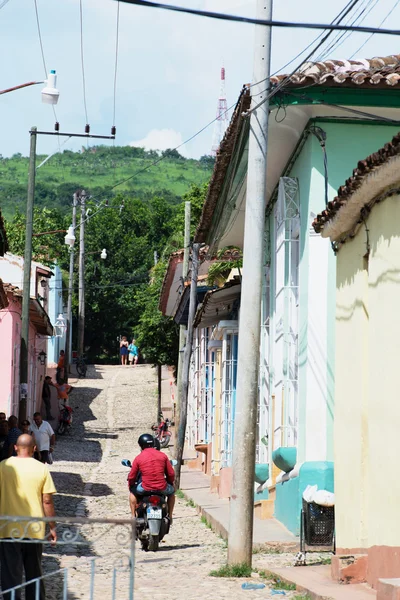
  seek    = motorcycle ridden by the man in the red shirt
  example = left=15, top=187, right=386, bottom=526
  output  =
left=121, top=458, right=176, bottom=552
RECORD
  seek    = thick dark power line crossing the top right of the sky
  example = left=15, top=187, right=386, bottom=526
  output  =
left=118, top=0, right=400, bottom=35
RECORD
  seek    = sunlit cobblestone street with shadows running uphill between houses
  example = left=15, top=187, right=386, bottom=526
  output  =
left=45, top=366, right=300, bottom=600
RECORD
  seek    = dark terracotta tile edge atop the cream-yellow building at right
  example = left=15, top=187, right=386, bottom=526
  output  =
left=312, top=133, right=400, bottom=233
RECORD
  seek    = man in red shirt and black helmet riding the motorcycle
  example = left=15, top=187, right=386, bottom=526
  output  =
left=128, top=433, right=175, bottom=524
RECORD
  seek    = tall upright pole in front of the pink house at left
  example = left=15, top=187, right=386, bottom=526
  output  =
left=18, top=127, right=37, bottom=422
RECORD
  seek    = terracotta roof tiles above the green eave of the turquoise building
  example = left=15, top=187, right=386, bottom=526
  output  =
left=271, top=54, right=400, bottom=88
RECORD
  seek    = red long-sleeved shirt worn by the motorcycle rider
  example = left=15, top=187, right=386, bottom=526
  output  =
left=128, top=448, right=175, bottom=492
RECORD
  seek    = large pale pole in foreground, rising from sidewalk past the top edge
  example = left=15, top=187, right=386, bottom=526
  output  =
left=228, top=0, right=273, bottom=565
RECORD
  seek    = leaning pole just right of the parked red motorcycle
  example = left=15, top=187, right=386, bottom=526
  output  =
left=175, top=244, right=200, bottom=489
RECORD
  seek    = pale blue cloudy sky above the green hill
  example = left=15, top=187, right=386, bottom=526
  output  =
left=0, top=0, right=400, bottom=158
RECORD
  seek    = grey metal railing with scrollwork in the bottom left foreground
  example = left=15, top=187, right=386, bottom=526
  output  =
left=0, top=516, right=136, bottom=600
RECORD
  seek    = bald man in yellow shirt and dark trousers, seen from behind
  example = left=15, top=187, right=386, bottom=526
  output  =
left=0, top=434, right=57, bottom=600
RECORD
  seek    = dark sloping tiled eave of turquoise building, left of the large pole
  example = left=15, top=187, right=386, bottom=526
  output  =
left=194, top=86, right=251, bottom=243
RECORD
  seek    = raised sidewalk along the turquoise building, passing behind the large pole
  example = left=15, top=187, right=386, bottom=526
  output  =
left=181, top=467, right=298, bottom=551
